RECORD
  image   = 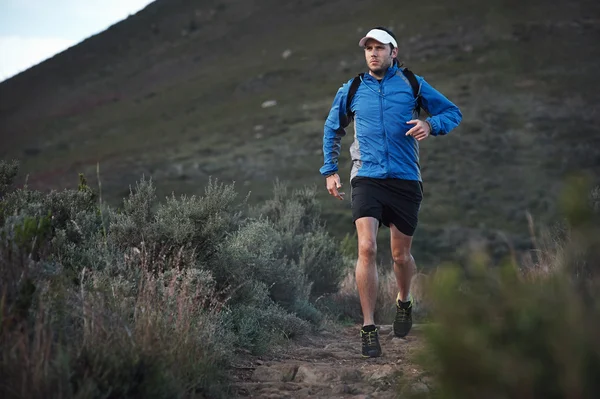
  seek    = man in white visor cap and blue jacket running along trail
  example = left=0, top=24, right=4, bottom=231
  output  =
left=320, top=27, right=462, bottom=357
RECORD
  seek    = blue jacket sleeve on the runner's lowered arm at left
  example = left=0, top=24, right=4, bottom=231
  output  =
left=319, top=83, right=350, bottom=176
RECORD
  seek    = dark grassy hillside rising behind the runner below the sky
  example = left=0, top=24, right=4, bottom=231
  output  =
left=0, top=0, right=600, bottom=265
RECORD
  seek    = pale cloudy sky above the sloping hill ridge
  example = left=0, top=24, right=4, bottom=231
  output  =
left=0, top=0, right=152, bottom=81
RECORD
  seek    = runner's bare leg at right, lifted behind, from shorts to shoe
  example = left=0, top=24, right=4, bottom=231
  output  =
left=390, top=224, right=417, bottom=302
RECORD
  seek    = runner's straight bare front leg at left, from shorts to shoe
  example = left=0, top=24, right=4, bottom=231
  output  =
left=355, top=217, right=379, bottom=326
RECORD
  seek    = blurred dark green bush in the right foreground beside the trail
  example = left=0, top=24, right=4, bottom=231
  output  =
left=410, top=186, right=600, bottom=399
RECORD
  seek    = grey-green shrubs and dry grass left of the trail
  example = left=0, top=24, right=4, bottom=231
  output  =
left=0, top=161, right=346, bottom=398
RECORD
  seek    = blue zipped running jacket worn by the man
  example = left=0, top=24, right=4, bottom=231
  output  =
left=320, top=64, right=462, bottom=181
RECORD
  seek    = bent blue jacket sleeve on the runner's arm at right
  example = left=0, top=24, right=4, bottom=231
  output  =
left=421, top=78, right=462, bottom=136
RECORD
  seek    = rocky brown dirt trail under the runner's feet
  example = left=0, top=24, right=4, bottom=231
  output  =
left=234, top=325, right=429, bottom=398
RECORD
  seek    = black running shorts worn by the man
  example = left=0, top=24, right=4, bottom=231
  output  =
left=351, top=176, right=423, bottom=236
